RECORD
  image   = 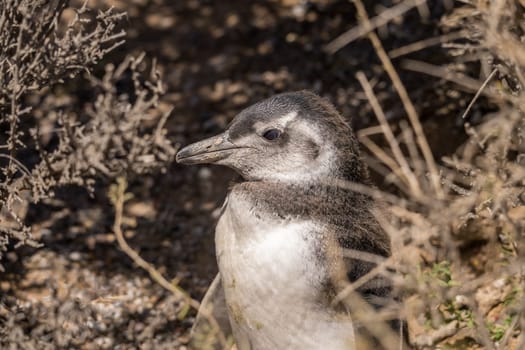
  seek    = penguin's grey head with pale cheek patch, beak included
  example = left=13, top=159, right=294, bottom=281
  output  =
left=176, top=91, right=366, bottom=182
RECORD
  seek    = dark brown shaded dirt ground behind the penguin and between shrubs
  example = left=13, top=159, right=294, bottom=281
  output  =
left=0, top=0, right=510, bottom=349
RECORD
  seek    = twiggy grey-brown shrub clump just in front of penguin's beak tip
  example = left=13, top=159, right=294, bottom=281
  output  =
left=31, top=55, right=175, bottom=199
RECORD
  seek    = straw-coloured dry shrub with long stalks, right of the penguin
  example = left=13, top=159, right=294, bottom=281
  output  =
left=350, top=0, right=525, bottom=349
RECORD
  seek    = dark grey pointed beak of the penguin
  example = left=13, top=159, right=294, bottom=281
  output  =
left=175, top=133, right=243, bottom=164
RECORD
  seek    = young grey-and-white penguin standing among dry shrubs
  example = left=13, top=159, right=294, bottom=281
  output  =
left=176, top=91, right=398, bottom=350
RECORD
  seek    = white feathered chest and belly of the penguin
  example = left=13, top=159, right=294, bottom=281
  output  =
left=216, top=199, right=353, bottom=350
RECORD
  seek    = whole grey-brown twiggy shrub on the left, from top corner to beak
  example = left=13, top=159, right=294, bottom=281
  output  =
left=0, top=0, right=175, bottom=266
